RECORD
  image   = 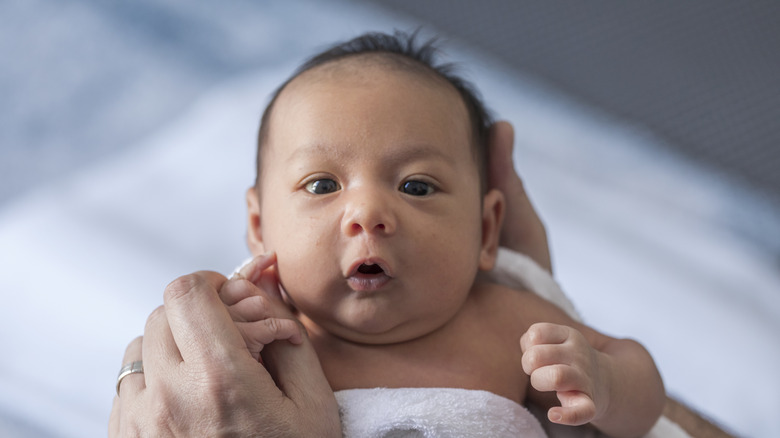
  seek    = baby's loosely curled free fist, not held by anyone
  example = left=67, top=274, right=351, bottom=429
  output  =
left=520, top=323, right=608, bottom=426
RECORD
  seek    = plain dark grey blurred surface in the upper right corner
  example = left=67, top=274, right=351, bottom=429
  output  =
left=373, top=0, right=780, bottom=204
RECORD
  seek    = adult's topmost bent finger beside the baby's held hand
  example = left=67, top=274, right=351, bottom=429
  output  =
left=164, top=271, right=246, bottom=363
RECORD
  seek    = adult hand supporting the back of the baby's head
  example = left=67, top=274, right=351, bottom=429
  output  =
left=488, top=121, right=552, bottom=272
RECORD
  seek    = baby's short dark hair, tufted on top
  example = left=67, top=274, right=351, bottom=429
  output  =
left=255, top=30, right=492, bottom=193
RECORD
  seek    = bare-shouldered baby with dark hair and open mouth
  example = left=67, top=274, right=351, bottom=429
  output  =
left=222, top=33, right=664, bottom=436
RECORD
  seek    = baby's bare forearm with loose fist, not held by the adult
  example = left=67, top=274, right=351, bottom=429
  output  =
left=520, top=312, right=665, bottom=437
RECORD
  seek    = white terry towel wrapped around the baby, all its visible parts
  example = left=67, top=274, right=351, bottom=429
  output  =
left=336, top=248, right=688, bottom=438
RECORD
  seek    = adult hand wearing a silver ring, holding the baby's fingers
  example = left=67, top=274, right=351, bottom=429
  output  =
left=109, top=266, right=341, bottom=437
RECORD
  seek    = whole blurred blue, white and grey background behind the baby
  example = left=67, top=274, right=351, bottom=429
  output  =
left=0, top=0, right=780, bottom=437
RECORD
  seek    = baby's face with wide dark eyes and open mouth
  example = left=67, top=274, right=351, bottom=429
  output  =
left=250, top=61, right=494, bottom=343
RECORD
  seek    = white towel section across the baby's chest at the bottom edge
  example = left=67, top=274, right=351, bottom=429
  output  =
left=336, top=388, right=546, bottom=438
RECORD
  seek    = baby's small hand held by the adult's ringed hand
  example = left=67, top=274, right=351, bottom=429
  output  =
left=219, top=254, right=303, bottom=362
